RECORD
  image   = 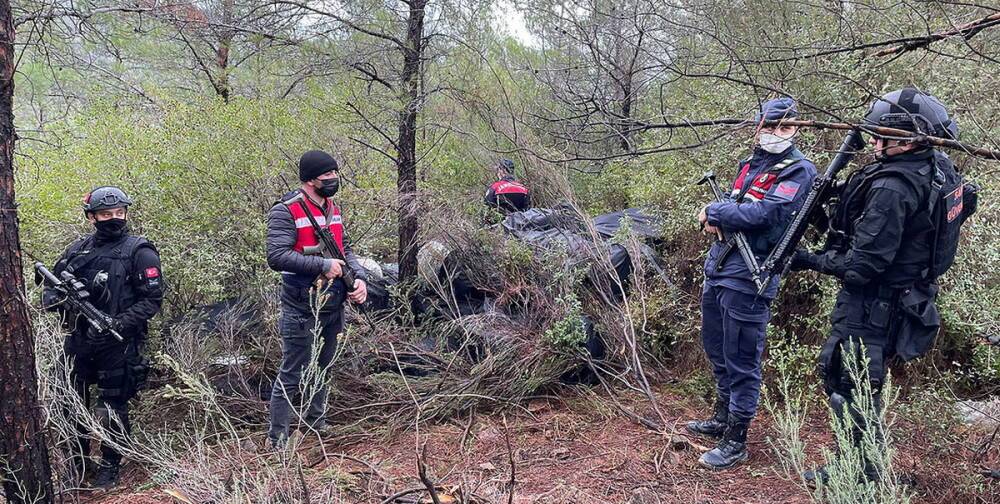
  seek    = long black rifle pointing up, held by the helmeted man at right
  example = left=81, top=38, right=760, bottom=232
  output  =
left=757, top=129, right=865, bottom=296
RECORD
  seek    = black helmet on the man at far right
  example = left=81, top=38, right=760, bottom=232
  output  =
left=864, top=87, right=958, bottom=140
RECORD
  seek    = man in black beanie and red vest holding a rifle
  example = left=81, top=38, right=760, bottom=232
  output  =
left=267, top=150, right=368, bottom=447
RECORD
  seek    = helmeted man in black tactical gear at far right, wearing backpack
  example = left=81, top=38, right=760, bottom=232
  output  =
left=792, top=88, right=974, bottom=480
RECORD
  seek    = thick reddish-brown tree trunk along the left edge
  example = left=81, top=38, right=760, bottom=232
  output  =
left=0, top=0, right=52, bottom=504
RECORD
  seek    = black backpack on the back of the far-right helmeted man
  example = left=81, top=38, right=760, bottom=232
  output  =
left=928, top=152, right=979, bottom=279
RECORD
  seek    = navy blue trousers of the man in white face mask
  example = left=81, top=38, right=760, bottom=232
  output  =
left=701, top=284, right=771, bottom=420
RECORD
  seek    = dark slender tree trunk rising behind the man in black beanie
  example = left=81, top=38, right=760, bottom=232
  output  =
left=396, top=0, right=427, bottom=282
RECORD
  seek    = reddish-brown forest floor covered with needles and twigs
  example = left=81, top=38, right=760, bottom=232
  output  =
left=62, top=386, right=1000, bottom=504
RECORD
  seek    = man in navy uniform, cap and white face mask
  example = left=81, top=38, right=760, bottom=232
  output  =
left=687, top=98, right=816, bottom=469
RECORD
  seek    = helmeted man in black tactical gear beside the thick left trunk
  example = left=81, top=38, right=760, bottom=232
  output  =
left=43, top=187, right=163, bottom=488
